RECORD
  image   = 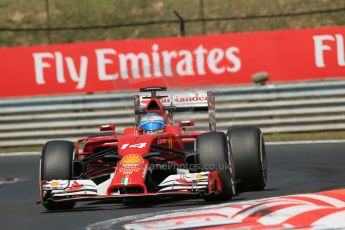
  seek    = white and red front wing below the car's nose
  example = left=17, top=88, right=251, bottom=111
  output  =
left=41, top=172, right=221, bottom=202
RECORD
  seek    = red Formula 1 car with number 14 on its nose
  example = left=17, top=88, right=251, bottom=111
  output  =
left=40, top=87, right=267, bottom=210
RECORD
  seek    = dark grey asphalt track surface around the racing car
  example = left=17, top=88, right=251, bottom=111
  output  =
left=0, top=142, right=345, bottom=230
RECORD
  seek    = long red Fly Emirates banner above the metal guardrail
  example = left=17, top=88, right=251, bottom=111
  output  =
left=0, top=27, right=345, bottom=98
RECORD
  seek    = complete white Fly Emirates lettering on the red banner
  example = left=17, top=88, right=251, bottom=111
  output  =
left=33, top=44, right=242, bottom=89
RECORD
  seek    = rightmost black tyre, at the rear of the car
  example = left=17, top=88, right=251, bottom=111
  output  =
left=227, top=127, right=267, bottom=192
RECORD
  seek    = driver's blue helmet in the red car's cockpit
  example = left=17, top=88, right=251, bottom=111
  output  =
left=139, top=113, right=165, bottom=134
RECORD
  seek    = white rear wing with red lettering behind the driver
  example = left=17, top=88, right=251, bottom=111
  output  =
left=134, top=91, right=216, bottom=131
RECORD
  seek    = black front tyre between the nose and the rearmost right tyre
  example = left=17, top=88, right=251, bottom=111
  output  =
left=196, top=132, right=235, bottom=201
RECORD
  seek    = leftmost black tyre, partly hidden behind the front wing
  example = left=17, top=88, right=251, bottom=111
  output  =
left=40, top=141, right=75, bottom=210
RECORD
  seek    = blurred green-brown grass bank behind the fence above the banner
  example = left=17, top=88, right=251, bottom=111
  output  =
left=0, top=0, right=345, bottom=46
